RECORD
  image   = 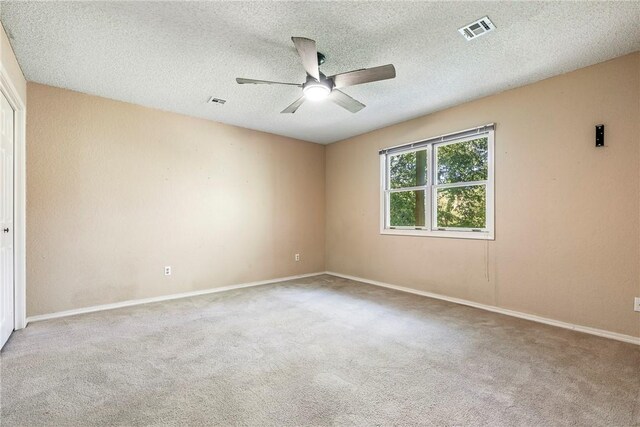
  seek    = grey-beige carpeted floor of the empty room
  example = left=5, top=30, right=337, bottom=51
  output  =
left=0, top=276, right=640, bottom=427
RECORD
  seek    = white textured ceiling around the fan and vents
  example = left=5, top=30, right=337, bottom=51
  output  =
left=0, top=1, right=640, bottom=143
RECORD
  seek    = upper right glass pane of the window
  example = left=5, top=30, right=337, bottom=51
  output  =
left=436, top=136, right=489, bottom=184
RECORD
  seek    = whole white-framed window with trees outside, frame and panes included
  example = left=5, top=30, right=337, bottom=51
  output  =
left=380, top=124, right=494, bottom=239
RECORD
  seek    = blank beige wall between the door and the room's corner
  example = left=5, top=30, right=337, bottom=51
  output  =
left=27, top=83, right=325, bottom=316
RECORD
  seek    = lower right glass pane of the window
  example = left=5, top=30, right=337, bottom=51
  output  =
left=436, top=185, right=487, bottom=228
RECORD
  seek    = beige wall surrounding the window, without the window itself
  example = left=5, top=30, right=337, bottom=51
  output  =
left=326, top=53, right=640, bottom=336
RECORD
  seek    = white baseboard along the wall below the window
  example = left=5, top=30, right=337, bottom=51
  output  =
left=325, top=271, right=640, bottom=345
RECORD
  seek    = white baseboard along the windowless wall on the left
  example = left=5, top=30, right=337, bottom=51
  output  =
left=27, top=271, right=324, bottom=323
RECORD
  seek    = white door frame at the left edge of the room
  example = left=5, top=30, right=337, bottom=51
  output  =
left=0, top=64, right=27, bottom=330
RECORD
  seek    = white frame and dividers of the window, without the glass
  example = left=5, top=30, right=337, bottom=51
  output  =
left=380, top=124, right=495, bottom=240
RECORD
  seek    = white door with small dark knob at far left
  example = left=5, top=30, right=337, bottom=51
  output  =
left=0, top=93, right=14, bottom=348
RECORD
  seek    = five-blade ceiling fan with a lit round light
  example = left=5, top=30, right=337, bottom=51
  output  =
left=236, top=37, right=396, bottom=113
